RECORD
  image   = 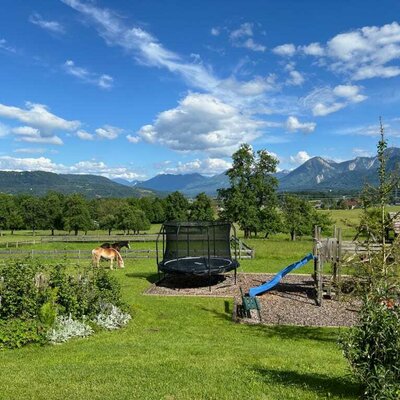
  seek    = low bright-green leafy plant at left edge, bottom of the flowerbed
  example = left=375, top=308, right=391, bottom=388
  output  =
left=0, top=318, right=45, bottom=349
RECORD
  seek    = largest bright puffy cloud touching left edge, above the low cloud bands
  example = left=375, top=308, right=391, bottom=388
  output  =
left=0, top=102, right=81, bottom=137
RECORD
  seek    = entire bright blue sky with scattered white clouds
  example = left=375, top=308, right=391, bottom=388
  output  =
left=0, top=0, right=400, bottom=180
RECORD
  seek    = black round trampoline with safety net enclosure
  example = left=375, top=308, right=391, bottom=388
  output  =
left=156, top=222, right=239, bottom=283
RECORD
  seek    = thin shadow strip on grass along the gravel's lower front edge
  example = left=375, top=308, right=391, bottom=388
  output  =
left=246, top=325, right=340, bottom=343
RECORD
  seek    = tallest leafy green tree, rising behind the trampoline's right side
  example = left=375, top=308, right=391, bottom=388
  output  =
left=218, top=144, right=278, bottom=238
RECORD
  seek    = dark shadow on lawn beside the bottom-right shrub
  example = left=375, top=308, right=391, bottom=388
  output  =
left=253, top=367, right=360, bottom=399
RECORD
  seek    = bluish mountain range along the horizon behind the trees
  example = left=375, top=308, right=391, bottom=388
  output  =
left=0, top=147, right=400, bottom=198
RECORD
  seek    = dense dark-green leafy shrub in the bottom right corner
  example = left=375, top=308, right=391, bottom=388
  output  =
left=342, top=295, right=400, bottom=400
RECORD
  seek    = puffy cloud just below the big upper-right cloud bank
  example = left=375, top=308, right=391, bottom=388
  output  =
left=301, top=85, right=367, bottom=117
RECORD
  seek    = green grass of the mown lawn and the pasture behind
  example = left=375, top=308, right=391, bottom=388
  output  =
left=0, top=227, right=358, bottom=400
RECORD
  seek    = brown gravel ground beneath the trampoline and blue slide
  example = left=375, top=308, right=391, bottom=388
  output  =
left=145, top=273, right=359, bottom=326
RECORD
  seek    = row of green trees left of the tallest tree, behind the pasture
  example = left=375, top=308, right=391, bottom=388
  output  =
left=0, top=192, right=214, bottom=235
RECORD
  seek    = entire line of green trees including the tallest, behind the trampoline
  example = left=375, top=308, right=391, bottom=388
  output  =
left=0, top=144, right=332, bottom=240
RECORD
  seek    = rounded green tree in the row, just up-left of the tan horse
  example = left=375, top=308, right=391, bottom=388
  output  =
left=64, top=194, right=92, bottom=235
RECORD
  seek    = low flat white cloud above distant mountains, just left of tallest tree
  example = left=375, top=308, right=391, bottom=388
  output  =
left=164, top=158, right=232, bottom=175
